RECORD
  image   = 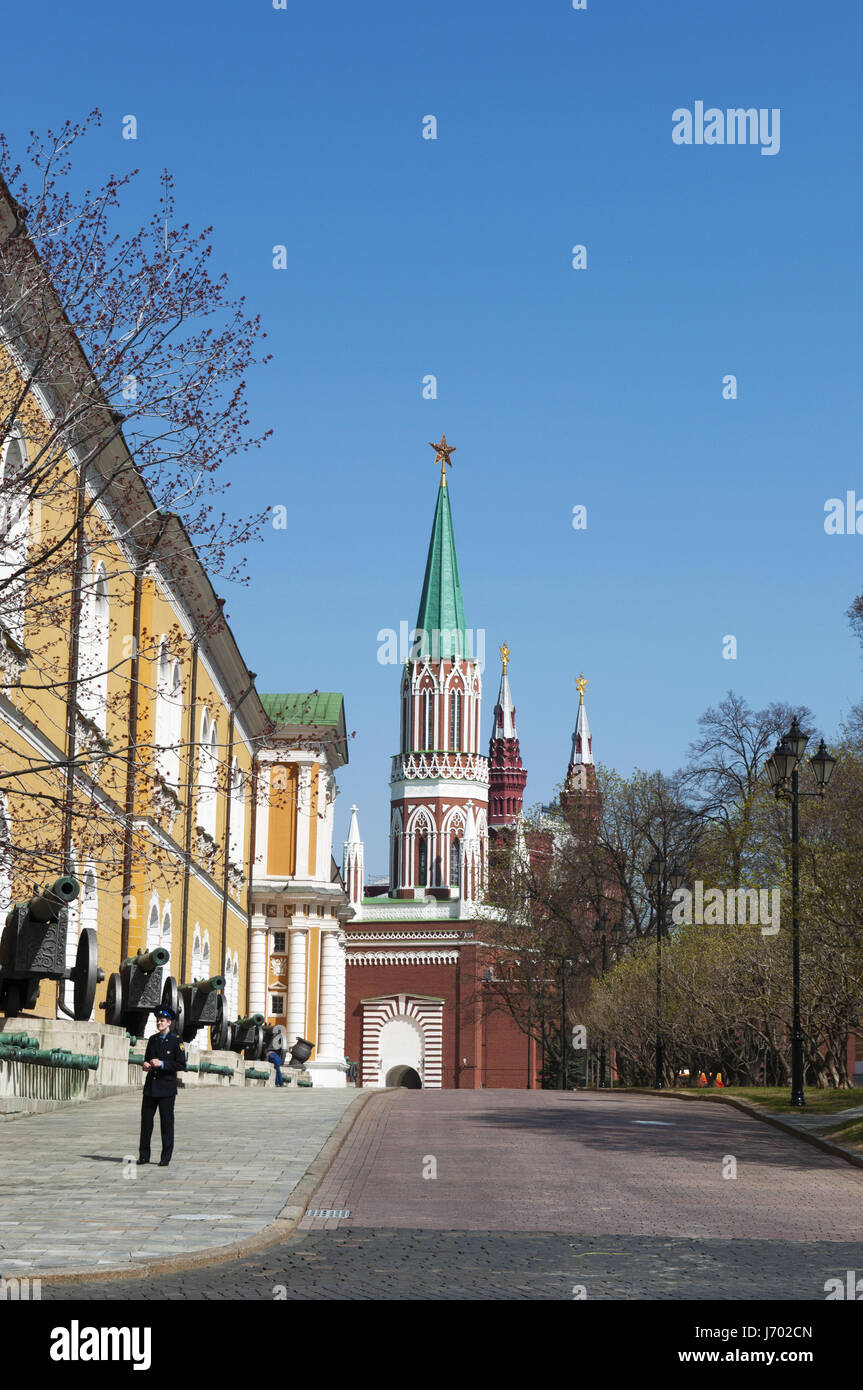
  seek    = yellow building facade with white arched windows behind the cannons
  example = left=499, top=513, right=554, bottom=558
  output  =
left=0, top=173, right=350, bottom=1051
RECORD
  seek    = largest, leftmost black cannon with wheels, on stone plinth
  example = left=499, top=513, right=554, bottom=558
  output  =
left=0, top=874, right=104, bottom=1022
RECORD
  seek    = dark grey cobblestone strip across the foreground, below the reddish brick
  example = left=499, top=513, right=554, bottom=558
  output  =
left=48, top=1227, right=863, bottom=1301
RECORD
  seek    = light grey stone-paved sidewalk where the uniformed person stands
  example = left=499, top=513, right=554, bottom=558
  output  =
left=0, top=1087, right=357, bottom=1276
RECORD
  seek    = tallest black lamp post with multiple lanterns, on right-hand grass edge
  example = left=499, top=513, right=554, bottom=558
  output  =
left=766, top=714, right=837, bottom=1109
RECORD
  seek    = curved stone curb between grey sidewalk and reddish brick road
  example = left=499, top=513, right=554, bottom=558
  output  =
left=28, top=1088, right=388, bottom=1284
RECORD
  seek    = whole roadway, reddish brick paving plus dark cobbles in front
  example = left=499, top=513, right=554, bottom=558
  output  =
left=43, top=1091, right=863, bottom=1301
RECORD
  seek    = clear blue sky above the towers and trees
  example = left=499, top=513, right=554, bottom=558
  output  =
left=3, top=0, right=863, bottom=873
